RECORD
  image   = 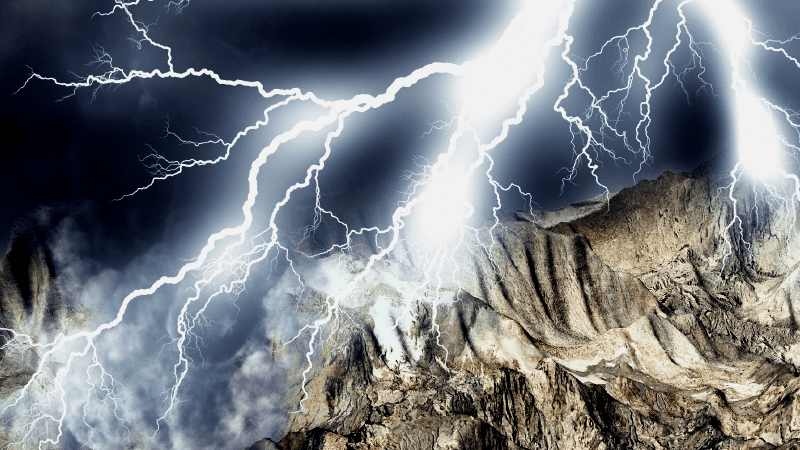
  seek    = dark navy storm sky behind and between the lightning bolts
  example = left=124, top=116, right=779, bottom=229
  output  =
left=0, top=0, right=726, bottom=260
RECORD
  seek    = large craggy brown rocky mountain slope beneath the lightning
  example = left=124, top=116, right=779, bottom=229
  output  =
left=268, top=166, right=800, bottom=450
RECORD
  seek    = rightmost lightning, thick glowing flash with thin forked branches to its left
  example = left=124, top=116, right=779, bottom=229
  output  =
left=554, top=0, right=800, bottom=282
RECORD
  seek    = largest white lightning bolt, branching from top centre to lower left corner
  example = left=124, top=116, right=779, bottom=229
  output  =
left=2, top=0, right=573, bottom=447
